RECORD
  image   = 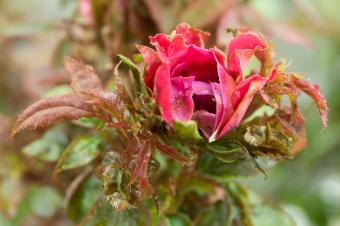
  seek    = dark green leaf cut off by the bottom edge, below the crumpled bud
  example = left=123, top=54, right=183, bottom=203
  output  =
left=80, top=201, right=151, bottom=226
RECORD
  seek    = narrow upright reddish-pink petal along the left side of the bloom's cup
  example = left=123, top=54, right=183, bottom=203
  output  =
left=154, top=64, right=173, bottom=123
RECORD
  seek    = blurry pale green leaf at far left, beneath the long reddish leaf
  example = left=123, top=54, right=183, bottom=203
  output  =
left=22, top=125, right=68, bottom=162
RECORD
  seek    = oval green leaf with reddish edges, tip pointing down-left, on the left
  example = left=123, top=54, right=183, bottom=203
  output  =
left=56, top=135, right=103, bottom=172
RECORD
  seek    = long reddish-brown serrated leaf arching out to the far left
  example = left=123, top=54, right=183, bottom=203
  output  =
left=11, top=94, right=94, bottom=136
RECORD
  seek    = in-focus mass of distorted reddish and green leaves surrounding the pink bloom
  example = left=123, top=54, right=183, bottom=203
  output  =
left=12, top=31, right=327, bottom=225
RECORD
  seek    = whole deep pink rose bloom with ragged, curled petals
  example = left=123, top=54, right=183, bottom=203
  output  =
left=137, top=23, right=268, bottom=141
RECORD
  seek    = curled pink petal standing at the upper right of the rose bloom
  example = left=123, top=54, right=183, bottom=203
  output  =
left=228, top=33, right=266, bottom=80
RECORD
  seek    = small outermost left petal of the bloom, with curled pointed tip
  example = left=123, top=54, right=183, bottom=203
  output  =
left=137, top=45, right=161, bottom=89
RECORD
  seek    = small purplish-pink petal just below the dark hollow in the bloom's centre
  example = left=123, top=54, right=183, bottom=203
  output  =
left=192, top=110, right=215, bottom=138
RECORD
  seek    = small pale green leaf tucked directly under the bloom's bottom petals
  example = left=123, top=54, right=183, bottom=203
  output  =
left=174, top=120, right=202, bottom=141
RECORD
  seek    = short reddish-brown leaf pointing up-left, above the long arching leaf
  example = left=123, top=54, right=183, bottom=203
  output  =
left=65, top=57, right=103, bottom=94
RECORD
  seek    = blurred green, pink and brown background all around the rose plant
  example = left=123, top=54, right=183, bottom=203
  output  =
left=0, top=0, right=340, bottom=226
